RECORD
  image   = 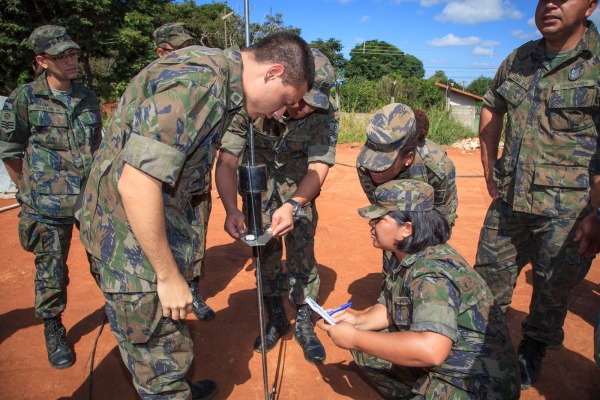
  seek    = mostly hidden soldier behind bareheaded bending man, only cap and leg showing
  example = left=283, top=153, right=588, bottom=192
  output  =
left=152, top=22, right=216, bottom=321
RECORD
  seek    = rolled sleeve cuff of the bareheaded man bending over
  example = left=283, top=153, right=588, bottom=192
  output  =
left=123, top=135, right=185, bottom=186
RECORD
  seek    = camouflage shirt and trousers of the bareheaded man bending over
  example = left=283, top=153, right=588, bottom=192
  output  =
left=80, top=46, right=243, bottom=399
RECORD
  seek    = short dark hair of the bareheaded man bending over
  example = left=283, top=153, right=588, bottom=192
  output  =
left=243, top=31, right=315, bottom=90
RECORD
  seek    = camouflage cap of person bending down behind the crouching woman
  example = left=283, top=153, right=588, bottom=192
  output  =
left=358, top=103, right=417, bottom=171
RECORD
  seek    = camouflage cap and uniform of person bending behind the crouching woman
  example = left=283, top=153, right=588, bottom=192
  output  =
left=356, top=104, right=458, bottom=282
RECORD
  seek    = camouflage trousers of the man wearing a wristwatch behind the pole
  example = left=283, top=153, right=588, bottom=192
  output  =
left=260, top=196, right=321, bottom=304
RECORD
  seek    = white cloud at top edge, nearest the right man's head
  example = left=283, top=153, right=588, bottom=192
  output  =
left=435, top=0, right=523, bottom=24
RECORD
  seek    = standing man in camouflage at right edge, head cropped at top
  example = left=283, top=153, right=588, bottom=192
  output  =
left=474, top=0, right=600, bottom=389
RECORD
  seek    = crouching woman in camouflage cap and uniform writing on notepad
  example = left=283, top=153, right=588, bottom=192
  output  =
left=318, top=180, right=520, bottom=400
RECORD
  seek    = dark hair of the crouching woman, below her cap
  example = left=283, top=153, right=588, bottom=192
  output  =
left=389, top=208, right=450, bottom=254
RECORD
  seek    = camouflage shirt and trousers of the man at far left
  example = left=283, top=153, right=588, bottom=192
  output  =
left=0, top=73, right=102, bottom=319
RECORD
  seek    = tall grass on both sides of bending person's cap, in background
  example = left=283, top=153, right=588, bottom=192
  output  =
left=338, top=108, right=477, bottom=145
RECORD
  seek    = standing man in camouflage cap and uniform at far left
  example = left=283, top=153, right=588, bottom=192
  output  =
left=0, top=25, right=102, bottom=369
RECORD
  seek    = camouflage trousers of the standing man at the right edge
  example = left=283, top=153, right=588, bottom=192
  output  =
left=474, top=199, right=592, bottom=345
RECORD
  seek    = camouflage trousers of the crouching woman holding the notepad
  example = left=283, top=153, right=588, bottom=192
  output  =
left=351, top=350, right=477, bottom=400
